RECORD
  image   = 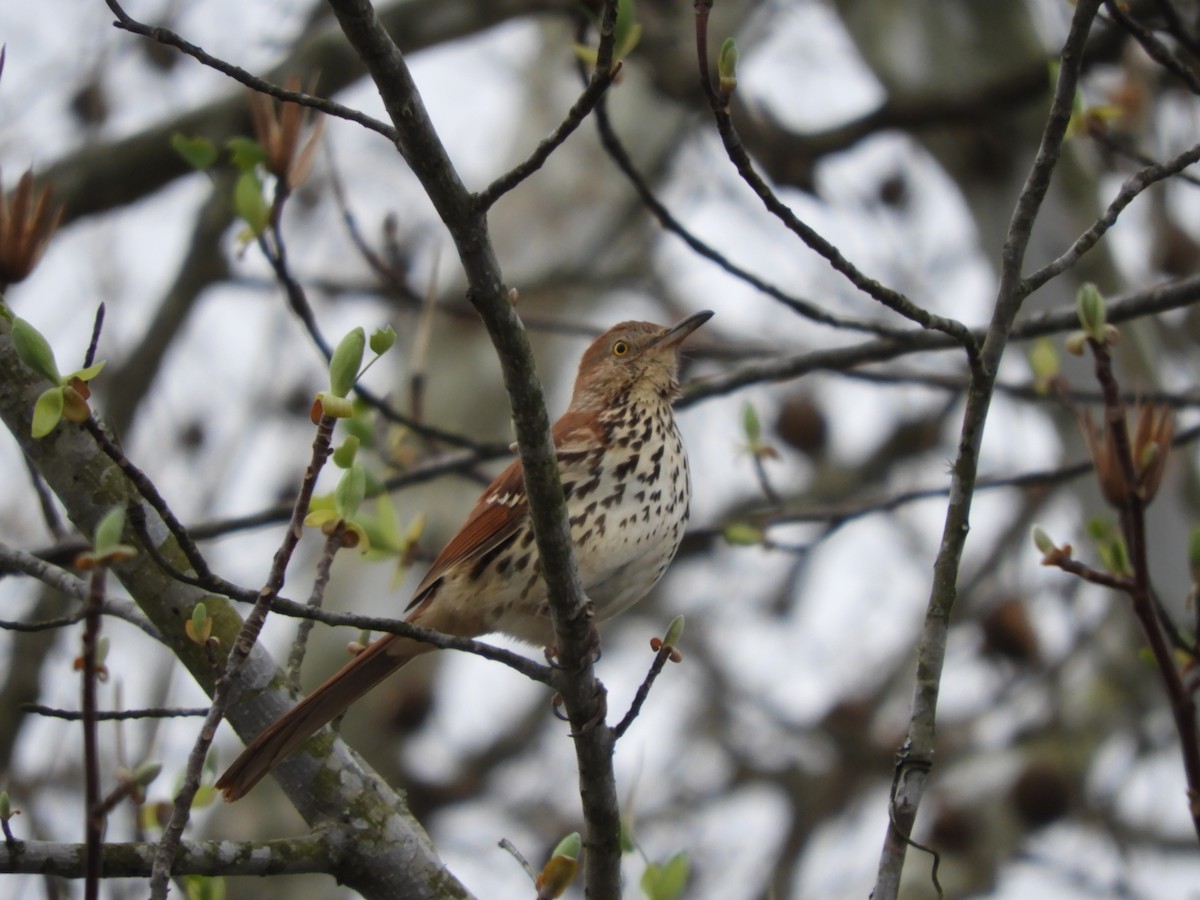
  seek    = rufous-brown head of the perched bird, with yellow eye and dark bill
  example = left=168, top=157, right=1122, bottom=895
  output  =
left=571, top=310, right=713, bottom=410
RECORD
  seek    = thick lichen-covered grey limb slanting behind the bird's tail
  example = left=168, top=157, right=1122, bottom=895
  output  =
left=0, top=318, right=469, bottom=900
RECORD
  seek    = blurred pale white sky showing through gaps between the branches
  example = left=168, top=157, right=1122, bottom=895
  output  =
left=0, top=0, right=1200, bottom=900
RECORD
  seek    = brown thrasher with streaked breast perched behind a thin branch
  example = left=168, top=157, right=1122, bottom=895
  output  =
left=217, top=310, right=713, bottom=800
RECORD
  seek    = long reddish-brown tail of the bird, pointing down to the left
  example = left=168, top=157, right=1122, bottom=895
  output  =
left=216, top=635, right=434, bottom=803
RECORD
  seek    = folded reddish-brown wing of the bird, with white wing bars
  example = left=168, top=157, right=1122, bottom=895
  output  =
left=404, top=412, right=600, bottom=612
